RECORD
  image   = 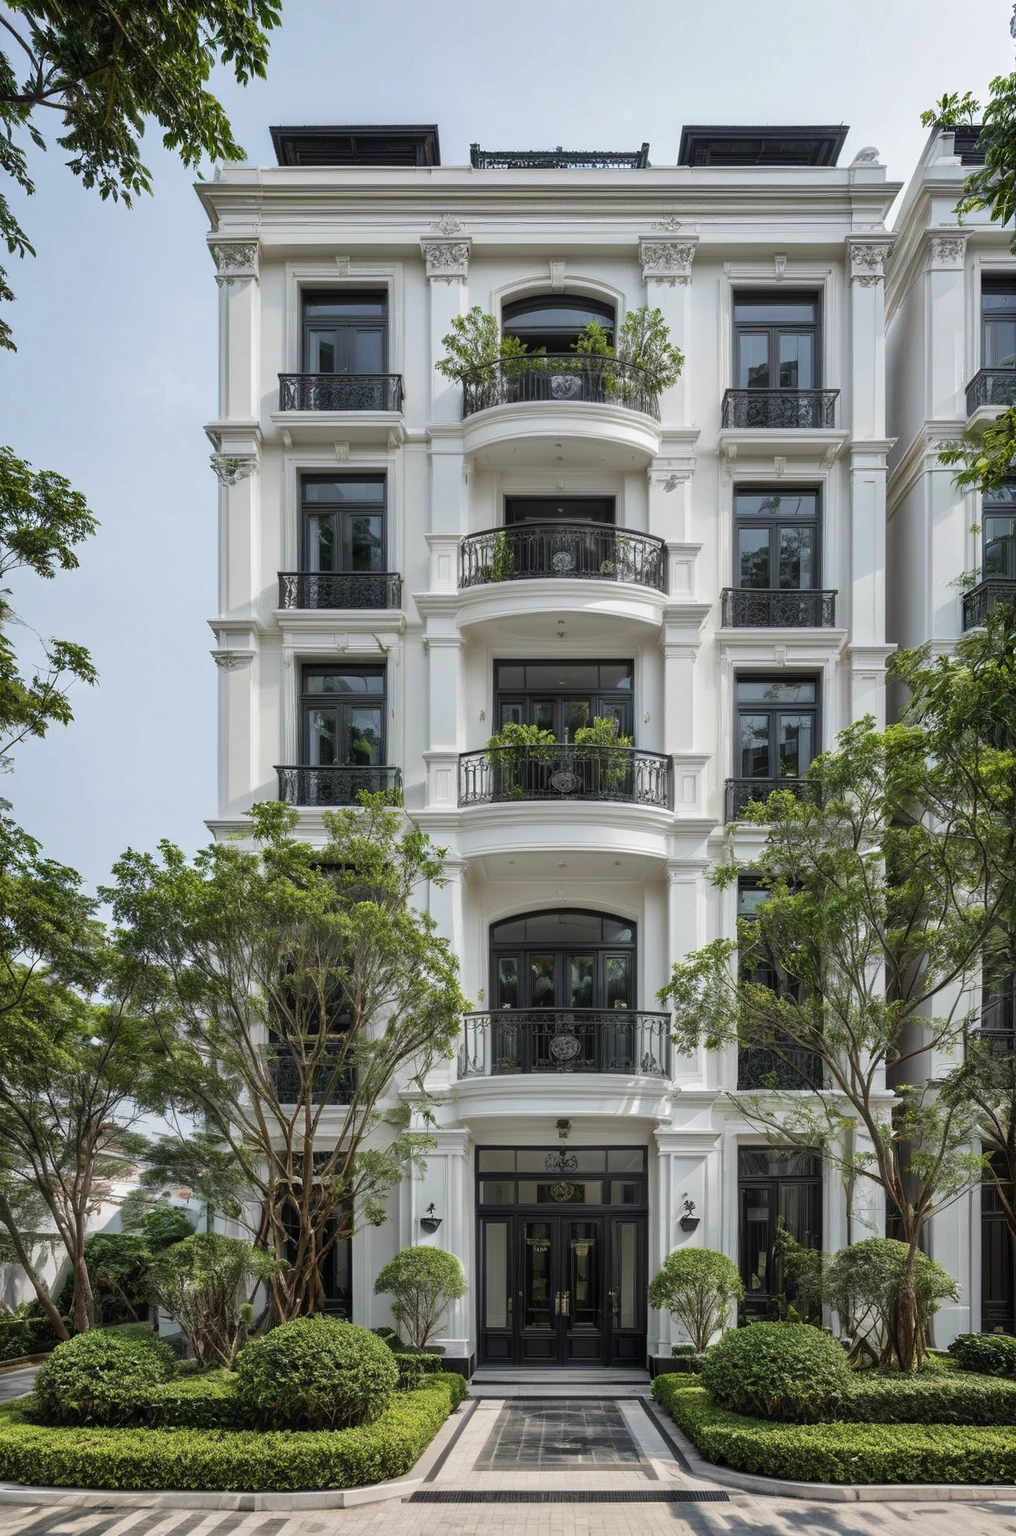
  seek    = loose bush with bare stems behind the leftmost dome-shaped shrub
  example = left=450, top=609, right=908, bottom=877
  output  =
left=149, top=1232, right=280, bottom=1369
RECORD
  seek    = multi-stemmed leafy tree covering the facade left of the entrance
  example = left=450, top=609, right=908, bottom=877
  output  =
left=105, top=794, right=466, bottom=1321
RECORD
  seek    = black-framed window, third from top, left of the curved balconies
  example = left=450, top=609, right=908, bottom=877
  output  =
left=301, top=667, right=384, bottom=768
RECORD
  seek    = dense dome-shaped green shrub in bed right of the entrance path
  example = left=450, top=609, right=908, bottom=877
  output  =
left=699, top=1322, right=850, bottom=1424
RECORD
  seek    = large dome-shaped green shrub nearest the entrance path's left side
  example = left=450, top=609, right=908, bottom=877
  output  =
left=237, top=1318, right=398, bottom=1430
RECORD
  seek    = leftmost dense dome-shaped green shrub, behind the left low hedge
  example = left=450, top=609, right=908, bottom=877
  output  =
left=35, top=1329, right=172, bottom=1425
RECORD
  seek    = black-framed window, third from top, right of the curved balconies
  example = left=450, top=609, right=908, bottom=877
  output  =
left=736, top=676, right=819, bottom=779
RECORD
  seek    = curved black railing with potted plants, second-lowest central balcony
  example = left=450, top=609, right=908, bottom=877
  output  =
left=458, top=745, right=673, bottom=811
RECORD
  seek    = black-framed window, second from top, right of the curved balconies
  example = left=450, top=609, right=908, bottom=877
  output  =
left=733, top=485, right=821, bottom=591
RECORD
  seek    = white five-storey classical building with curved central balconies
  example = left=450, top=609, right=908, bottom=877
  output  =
left=200, top=127, right=897, bottom=1366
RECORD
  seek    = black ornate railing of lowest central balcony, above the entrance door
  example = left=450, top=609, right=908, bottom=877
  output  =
left=458, top=1008, right=670, bottom=1078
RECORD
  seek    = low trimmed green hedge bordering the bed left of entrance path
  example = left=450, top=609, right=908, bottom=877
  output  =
left=0, top=1373, right=467, bottom=1493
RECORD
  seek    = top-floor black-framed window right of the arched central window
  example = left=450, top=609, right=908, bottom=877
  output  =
left=733, top=293, right=821, bottom=389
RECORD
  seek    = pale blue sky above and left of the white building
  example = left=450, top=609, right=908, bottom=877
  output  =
left=0, top=0, right=1013, bottom=883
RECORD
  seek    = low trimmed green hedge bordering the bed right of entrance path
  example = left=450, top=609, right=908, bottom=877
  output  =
left=653, top=1376, right=1016, bottom=1482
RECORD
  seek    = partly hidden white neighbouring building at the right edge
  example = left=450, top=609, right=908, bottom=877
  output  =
left=887, top=126, right=1016, bottom=1339
